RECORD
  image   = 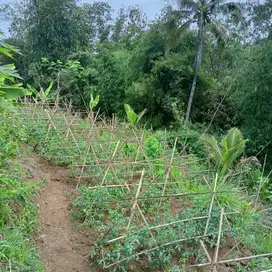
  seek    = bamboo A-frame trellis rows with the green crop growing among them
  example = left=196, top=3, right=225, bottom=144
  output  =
left=19, top=103, right=272, bottom=271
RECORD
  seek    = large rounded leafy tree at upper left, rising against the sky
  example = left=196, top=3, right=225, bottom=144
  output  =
left=10, top=0, right=86, bottom=61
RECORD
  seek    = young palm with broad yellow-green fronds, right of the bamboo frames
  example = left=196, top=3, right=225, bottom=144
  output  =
left=201, top=128, right=247, bottom=177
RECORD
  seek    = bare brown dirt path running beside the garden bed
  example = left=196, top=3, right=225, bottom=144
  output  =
left=20, top=153, right=94, bottom=272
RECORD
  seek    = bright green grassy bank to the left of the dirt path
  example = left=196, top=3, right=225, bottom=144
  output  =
left=0, top=102, right=44, bottom=272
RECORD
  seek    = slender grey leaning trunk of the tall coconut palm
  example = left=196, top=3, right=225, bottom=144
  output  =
left=184, top=11, right=204, bottom=127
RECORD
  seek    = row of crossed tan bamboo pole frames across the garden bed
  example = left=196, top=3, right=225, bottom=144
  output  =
left=19, top=100, right=272, bottom=271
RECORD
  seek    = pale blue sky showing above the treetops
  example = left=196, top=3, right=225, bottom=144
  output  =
left=0, top=0, right=166, bottom=34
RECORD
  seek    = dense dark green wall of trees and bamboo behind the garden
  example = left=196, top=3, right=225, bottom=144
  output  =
left=2, top=0, right=272, bottom=166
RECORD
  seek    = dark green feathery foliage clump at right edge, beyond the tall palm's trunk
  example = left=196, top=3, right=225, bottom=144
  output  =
left=231, top=40, right=272, bottom=164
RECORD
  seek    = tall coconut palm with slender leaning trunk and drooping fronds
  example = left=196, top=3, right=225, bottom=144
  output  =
left=167, top=0, right=241, bottom=127
